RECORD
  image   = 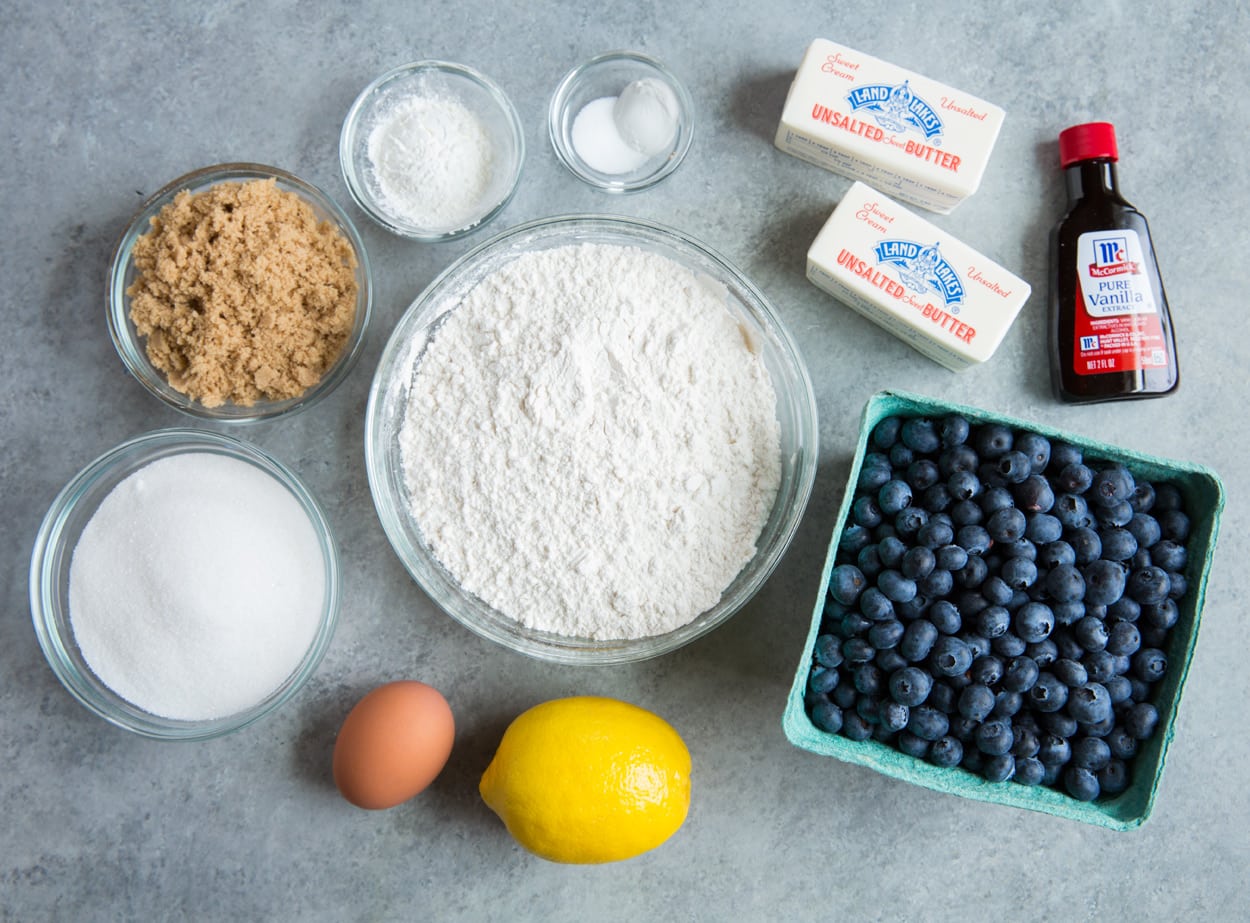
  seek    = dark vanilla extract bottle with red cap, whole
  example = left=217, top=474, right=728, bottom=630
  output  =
left=1050, top=121, right=1180, bottom=403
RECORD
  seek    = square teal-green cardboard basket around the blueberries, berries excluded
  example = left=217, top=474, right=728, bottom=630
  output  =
left=783, top=391, right=1224, bottom=830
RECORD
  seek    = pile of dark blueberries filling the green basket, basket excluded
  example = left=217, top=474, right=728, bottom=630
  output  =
left=806, top=415, right=1190, bottom=800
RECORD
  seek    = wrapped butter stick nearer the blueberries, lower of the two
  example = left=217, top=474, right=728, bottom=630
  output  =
left=808, top=183, right=1030, bottom=371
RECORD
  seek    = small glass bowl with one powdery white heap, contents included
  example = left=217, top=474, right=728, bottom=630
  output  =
left=339, top=60, right=525, bottom=241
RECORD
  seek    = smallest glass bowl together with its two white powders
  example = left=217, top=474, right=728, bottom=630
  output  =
left=548, top=51, right=694, bottom=193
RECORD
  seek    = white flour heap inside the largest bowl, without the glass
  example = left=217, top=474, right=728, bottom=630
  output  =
left=400, top=244, right=781, bottom=639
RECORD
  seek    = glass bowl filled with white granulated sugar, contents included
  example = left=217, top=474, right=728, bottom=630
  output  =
left=30, top=429, right=340, bottom=740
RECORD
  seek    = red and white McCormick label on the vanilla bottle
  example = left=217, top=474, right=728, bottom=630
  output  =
left=1073, top=229, right=1168, bottom=375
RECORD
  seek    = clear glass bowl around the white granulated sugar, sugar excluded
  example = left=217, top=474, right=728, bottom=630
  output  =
left=30, top=429, right=340, bottom=740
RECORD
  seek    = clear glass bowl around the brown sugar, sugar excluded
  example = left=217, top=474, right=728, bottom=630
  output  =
left=109, top=164, right=373, bottom=423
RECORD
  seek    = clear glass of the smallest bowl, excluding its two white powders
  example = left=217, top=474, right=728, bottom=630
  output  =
left=548, top=51, right=695, bottom=193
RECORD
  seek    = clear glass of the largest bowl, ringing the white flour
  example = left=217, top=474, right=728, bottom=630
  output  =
left=365, top=214, right=819, bottom=664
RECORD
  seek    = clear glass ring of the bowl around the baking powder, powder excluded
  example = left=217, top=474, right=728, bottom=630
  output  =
left=339, top=58, right=525, bottom=238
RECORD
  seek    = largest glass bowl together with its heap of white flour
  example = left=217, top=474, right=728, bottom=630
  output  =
left=365, top=216, right=818, bottom=663
